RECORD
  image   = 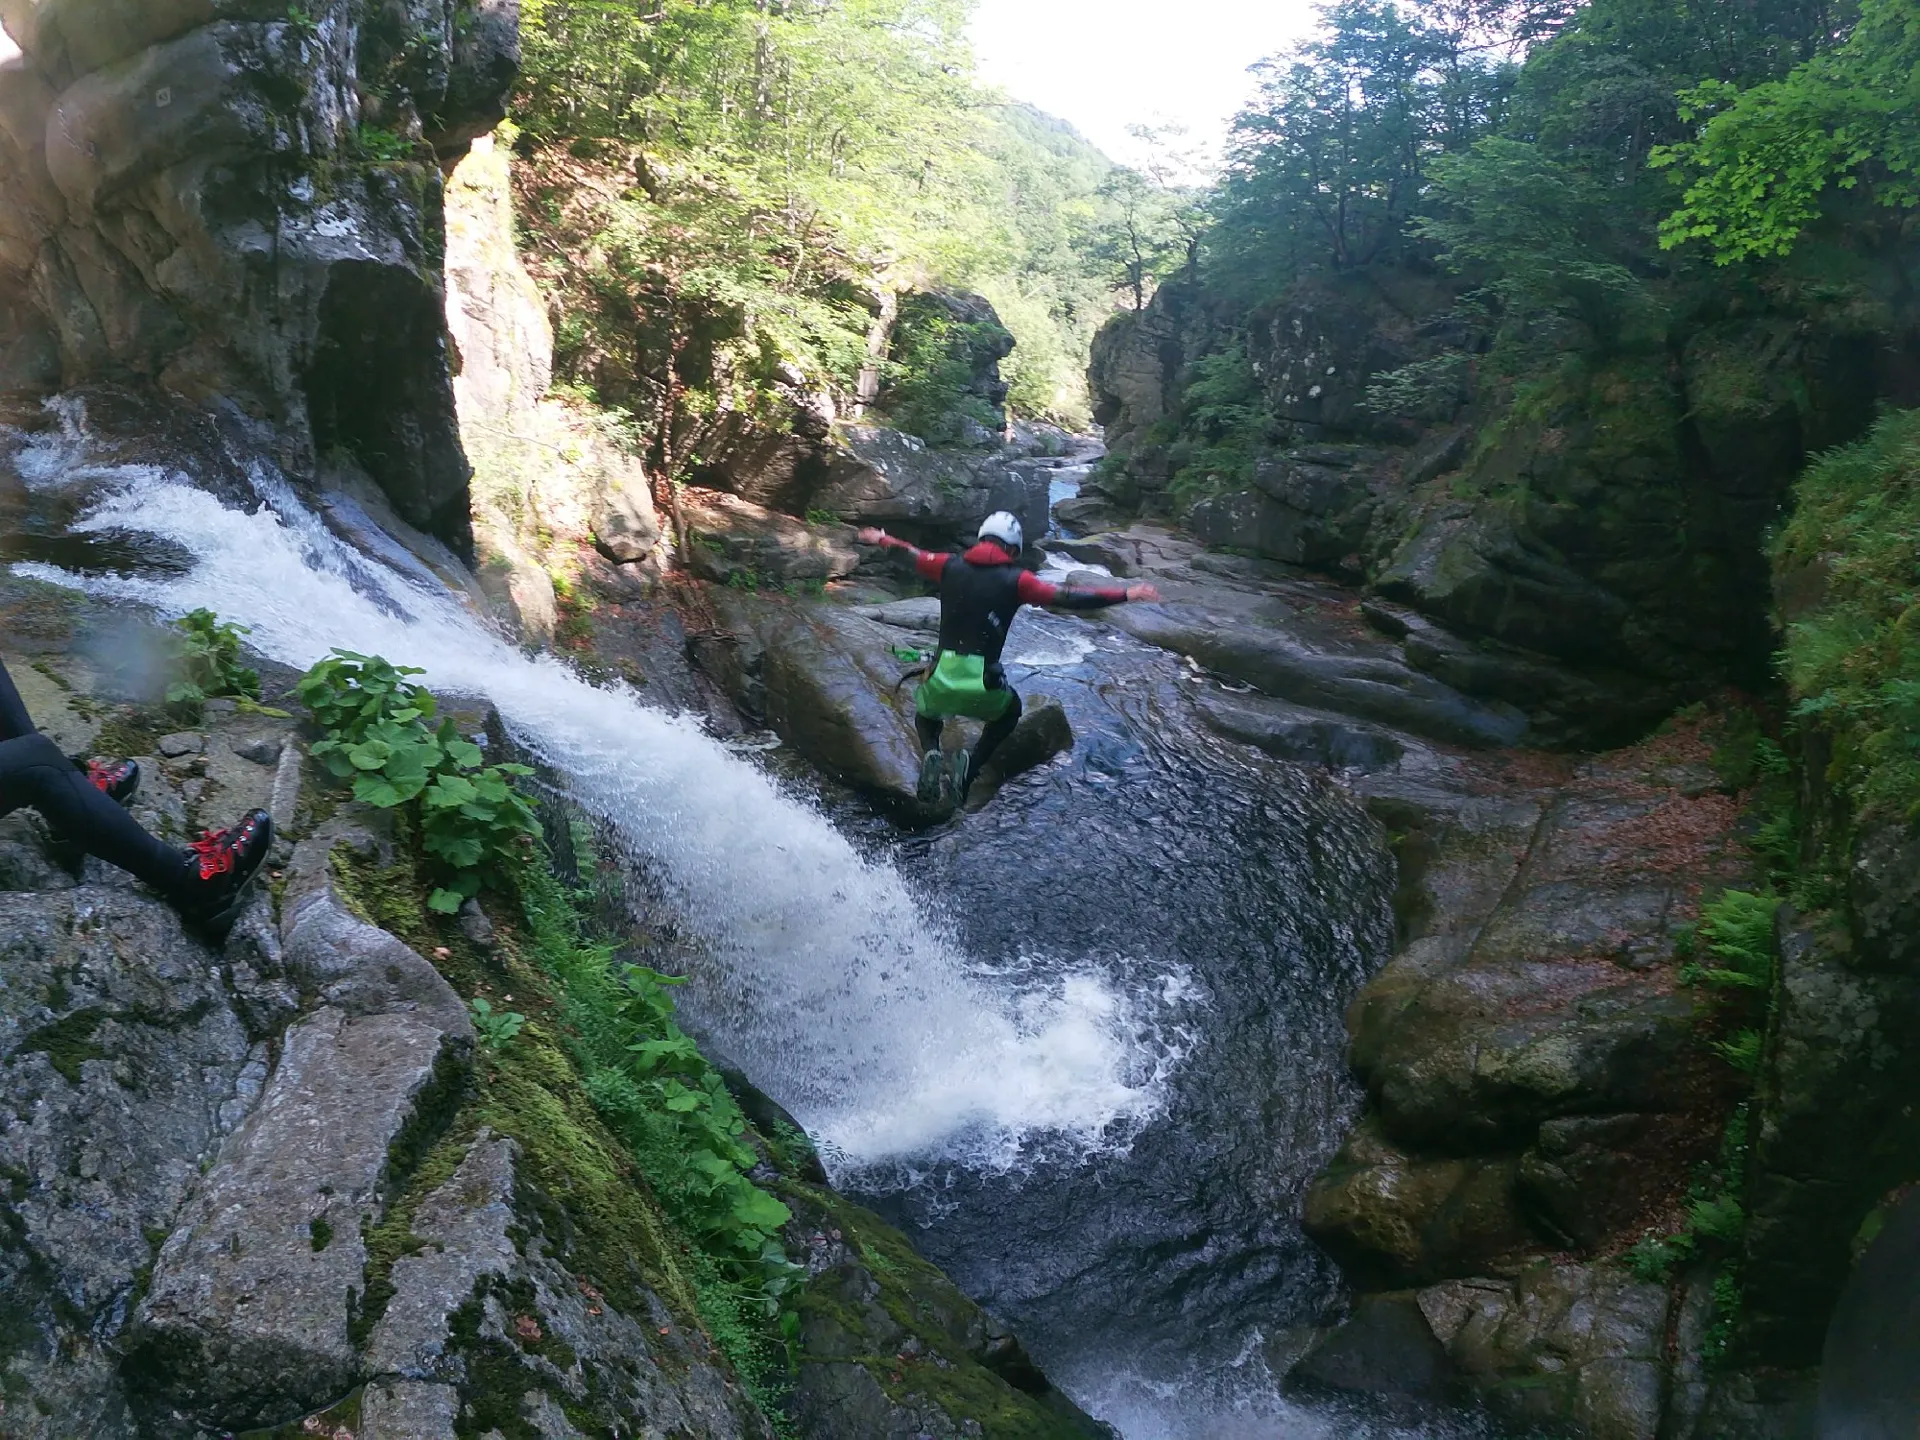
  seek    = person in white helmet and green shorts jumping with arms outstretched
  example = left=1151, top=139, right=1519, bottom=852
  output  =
left=858, top=511, right=1160, bottom=806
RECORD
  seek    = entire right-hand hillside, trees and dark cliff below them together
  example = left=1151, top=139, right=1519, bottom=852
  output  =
left=1094, top=0, right=1916, bottom=735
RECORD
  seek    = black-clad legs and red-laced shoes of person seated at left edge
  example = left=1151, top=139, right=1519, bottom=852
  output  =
left=0, top=664, right=273, bottom=927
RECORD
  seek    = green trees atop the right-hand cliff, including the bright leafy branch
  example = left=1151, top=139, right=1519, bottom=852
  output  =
left=1113, top=0, right=1916, bottom=492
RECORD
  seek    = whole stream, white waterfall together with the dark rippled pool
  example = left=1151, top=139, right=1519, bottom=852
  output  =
left=0, top=401, right=1489, bottom=1440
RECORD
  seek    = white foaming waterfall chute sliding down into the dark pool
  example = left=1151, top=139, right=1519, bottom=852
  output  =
left=13, top=409, right=1181, bottom=1173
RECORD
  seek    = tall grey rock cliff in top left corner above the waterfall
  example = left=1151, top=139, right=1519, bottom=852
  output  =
left=0, top=0, right=518, bottom=547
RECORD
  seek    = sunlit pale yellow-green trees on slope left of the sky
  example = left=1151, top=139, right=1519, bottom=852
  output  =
left=515, top=0, right=1116, bottom=443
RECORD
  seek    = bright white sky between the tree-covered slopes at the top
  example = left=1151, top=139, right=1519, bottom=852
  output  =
left=973, top=0, right=1317, bottom=171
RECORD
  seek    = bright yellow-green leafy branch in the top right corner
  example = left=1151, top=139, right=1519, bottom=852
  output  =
left=1655, top=0, right=1920, bottom=265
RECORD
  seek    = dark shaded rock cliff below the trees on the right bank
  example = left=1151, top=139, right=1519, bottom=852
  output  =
left=1092, top=261, right=1916, bottom=743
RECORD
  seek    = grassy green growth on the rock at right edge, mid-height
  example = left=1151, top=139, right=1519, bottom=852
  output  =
left=1774, top=411, right=1920, bottom=820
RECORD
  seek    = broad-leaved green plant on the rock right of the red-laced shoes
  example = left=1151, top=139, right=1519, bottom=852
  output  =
left=300, top=651, right=540, bottom=914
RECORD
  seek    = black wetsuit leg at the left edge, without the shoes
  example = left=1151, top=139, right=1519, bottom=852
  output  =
left=0, top=666, right=188, bottom=899
